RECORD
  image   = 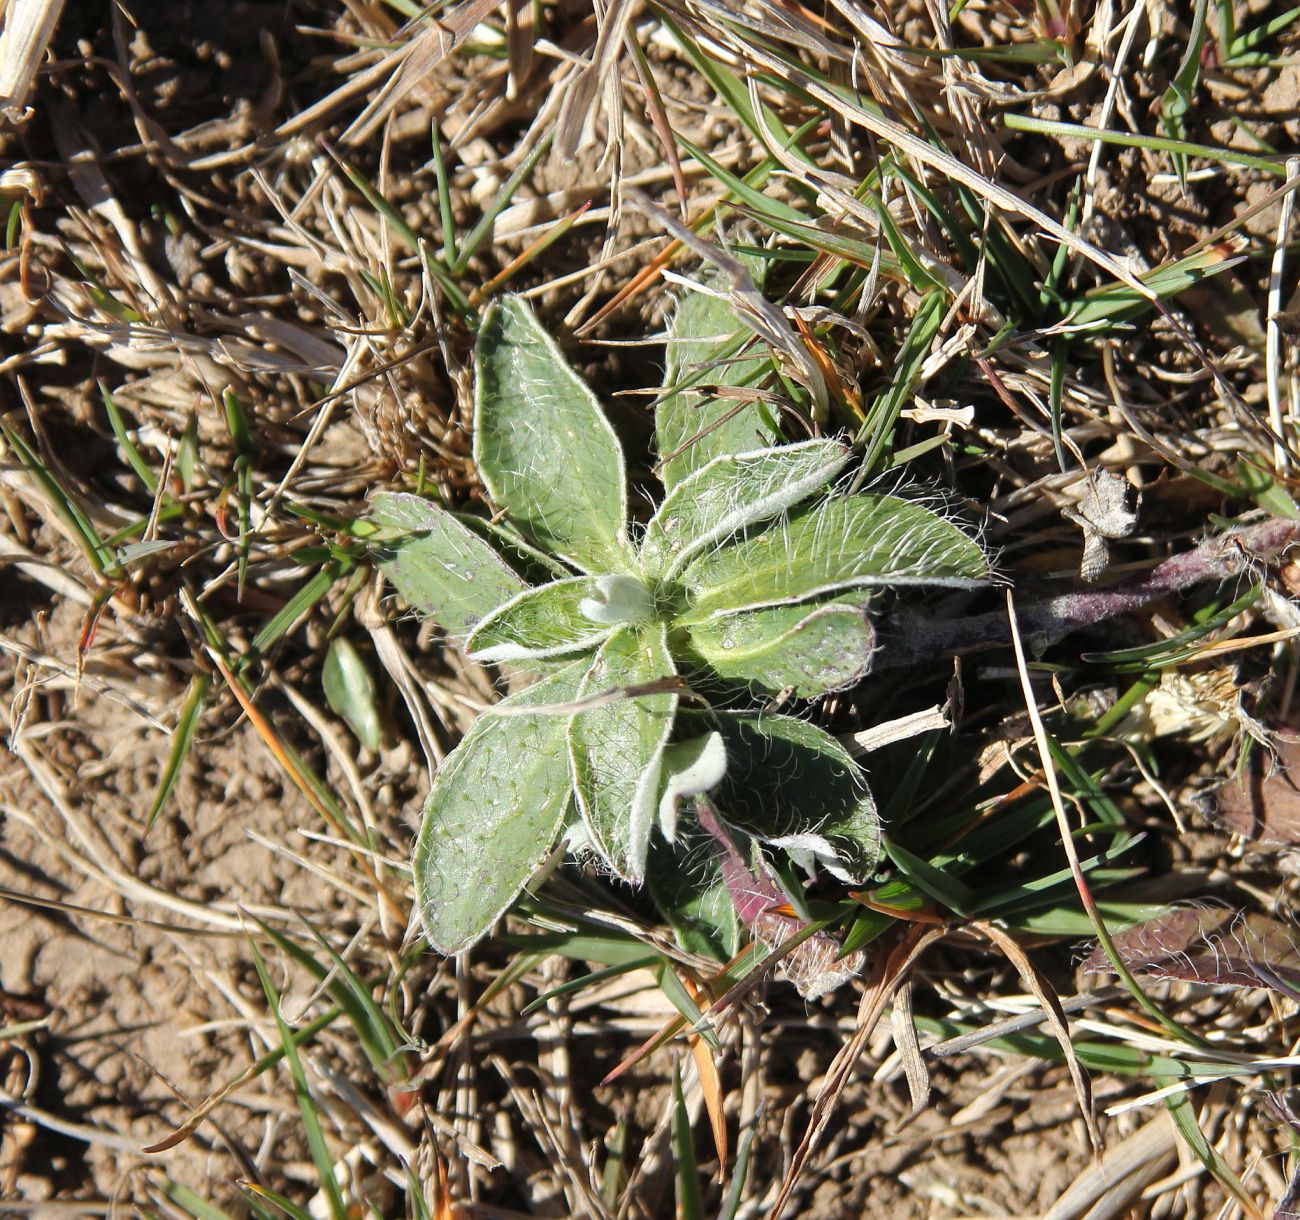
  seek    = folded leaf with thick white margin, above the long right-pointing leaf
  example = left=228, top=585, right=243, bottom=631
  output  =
left=641, top=440, right=849, bottom=580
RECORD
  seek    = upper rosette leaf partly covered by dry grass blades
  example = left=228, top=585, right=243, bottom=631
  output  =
left=655, top=282, right=780, bottom=492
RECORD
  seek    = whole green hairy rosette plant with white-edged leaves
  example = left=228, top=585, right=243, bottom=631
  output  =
left=372, top=295, right=988, bottom=953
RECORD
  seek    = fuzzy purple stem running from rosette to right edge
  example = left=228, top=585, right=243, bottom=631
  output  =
left=874, top=518, right=1300, bottom=670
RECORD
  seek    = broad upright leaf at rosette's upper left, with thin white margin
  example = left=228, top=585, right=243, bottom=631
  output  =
left=475, top=297, right=633, bottom=572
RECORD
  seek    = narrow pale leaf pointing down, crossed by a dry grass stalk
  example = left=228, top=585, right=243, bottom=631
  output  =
left=569, top=626, right=677, bottom=882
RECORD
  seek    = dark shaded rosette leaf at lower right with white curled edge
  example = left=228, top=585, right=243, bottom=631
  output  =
left=693, top=714, right=880, bottom=884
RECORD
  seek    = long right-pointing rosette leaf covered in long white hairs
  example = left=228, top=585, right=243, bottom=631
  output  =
left=677, top=494, right=989, bottom=626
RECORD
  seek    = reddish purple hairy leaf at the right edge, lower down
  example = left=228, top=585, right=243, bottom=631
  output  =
left=1083, top=907, right=1300, bottom=995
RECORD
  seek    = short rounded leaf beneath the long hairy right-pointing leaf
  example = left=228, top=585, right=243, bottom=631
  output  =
left=690, top=594, right=876, bottom=698
